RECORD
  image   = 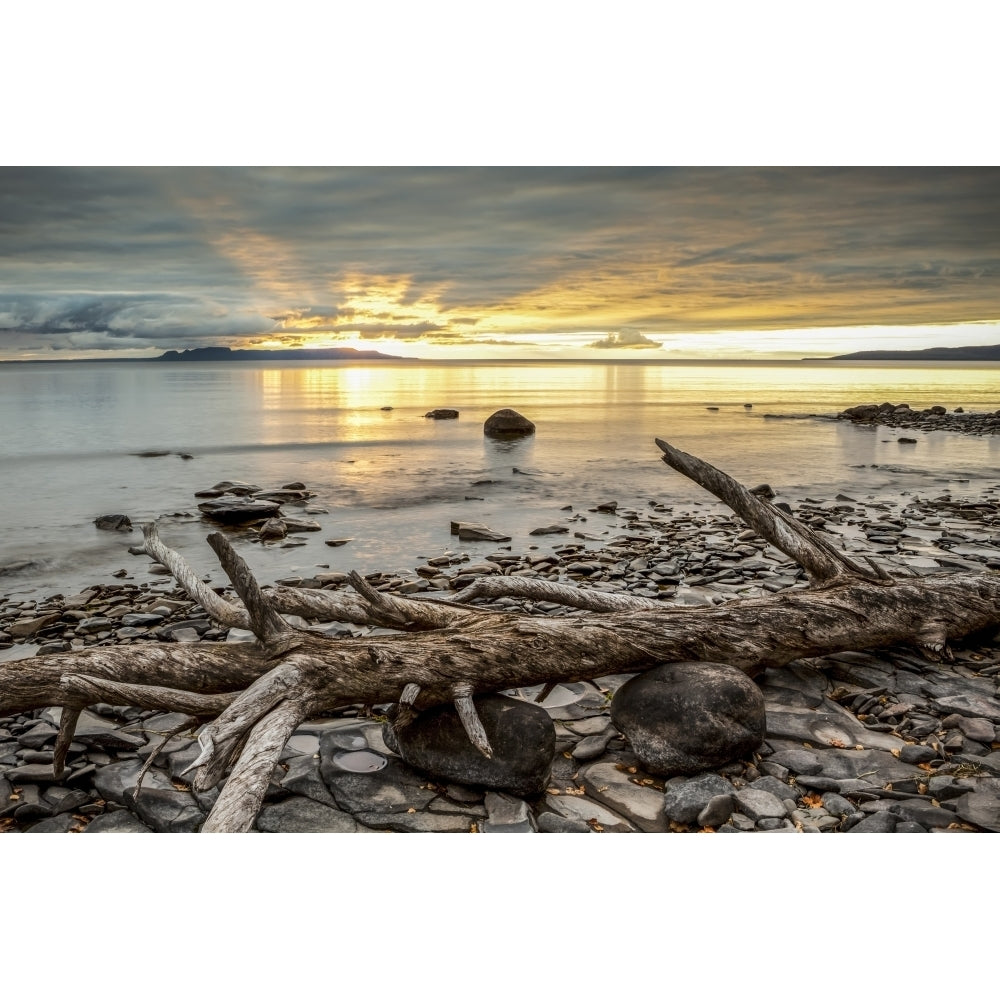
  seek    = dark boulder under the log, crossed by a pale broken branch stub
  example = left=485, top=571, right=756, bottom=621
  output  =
left=386, top=694, right=556, bottom=797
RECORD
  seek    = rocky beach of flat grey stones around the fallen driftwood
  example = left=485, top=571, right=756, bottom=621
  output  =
left=0, top=404, right=1000, bottom=833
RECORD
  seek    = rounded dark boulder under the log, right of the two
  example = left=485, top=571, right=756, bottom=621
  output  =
left=611, top=660, right=765, bottom=775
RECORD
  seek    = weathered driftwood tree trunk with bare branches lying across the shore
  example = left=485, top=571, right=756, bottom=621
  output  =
left=0, top=440, right=1000, bottom=832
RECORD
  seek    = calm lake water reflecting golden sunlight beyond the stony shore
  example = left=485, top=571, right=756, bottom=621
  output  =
left=0, top=362, right=1000, bottom=596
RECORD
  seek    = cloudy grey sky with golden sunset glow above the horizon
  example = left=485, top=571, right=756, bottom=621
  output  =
left=0, top=167, right=1000, bottom=360
